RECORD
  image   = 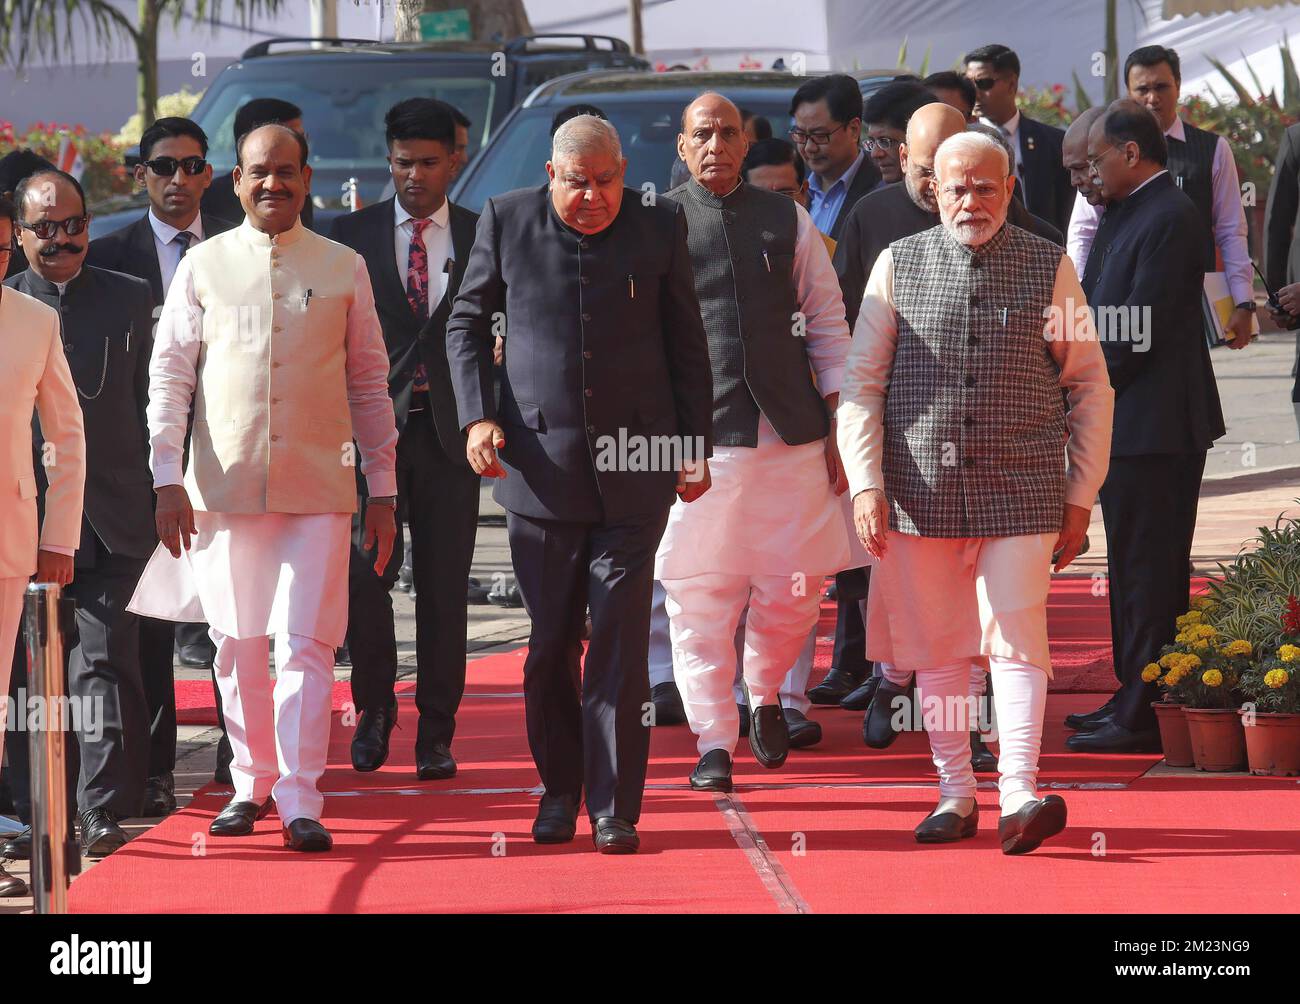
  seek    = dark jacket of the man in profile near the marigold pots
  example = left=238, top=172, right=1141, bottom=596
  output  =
left=1083, top=174, right=1223, bottom=456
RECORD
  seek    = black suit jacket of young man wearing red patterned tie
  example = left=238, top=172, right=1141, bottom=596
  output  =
left=329, top=199, right=478, bottom=468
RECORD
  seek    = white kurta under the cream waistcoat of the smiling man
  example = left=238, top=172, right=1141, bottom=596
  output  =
left=127, top=255, right=397, bottom=648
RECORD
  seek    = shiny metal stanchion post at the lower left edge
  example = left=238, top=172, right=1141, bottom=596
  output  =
left=23, top=583, right=81, bottom=913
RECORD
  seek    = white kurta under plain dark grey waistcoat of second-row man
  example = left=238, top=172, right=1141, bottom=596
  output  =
left=655, top=207, right=852, bottom=588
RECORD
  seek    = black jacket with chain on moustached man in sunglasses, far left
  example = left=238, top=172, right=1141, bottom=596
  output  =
left=5, top=265, right=157, bottom=566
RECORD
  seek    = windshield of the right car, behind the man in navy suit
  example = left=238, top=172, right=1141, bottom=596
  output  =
left=452, top=98, right=793, bottom=212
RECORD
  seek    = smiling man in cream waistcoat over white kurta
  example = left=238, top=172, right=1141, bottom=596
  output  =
left=131, top=126, right=397, bottom=851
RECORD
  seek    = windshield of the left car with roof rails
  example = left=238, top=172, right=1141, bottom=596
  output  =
left=196, top=57, right=497, bottom=173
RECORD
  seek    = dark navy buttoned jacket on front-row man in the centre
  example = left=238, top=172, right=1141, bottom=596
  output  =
left=447, top=186, right=714, bottom=523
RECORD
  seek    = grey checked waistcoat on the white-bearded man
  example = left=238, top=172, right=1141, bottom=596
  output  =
left=884, top=224, right=1066, bottom=537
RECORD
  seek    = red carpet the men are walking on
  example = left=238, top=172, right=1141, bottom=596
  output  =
left=70, top=639, right=1300, bottom=913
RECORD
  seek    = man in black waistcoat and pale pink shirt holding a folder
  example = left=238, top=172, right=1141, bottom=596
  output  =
left=1069, top=46, right=1256, bottom=349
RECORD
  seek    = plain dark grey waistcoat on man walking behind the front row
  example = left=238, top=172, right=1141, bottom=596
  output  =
left=668, top=179, right=831, bottom=446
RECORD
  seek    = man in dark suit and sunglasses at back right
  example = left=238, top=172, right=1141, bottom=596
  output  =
left=966, top=46, right=1074, bottom=234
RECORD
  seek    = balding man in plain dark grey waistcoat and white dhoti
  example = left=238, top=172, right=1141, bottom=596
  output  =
left=655, top=94, right=849, bottom=791
